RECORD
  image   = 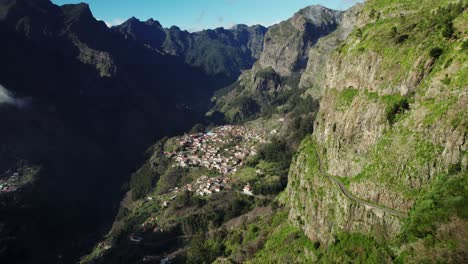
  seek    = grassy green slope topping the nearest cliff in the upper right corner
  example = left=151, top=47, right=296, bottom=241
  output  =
left=339, top=0, right=466, bottom=89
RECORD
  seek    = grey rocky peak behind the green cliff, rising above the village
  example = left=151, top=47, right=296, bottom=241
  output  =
left=209, top=5, right=348, bottom=122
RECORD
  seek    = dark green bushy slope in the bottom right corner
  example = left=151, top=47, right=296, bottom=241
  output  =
left=397, top=170, right=468, bottom=263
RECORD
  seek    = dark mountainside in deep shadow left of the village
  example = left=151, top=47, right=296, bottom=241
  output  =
left=0, top=0, right=252, bottom=263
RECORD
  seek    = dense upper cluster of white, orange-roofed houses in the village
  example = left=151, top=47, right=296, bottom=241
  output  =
left=164, top=125, right=265, bottom=174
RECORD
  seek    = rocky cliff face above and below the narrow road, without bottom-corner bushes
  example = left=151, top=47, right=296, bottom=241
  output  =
left=288, top=1, right=468, bottom=248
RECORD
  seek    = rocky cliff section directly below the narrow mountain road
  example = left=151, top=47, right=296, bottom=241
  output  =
left=287, top=138, right=402, bottom=246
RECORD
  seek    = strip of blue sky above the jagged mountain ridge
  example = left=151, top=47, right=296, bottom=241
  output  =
left=52, top=0, right=358, bottom=31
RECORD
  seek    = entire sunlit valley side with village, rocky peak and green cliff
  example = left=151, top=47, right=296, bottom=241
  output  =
left=81, top=0, right=468, bottom=263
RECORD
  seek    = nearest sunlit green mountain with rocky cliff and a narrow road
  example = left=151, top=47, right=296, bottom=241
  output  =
left=287, top=1, right=468, bottom=263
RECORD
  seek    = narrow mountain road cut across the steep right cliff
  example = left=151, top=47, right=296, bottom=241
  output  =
left=312, top=138, right=408, bottom=218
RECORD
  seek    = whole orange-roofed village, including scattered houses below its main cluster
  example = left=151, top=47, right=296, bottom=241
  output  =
left=129, top=125, right=277, bottom=243
